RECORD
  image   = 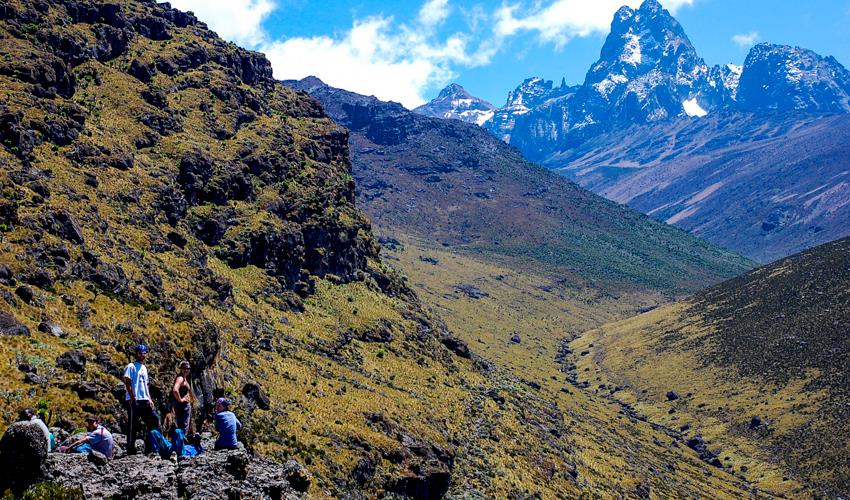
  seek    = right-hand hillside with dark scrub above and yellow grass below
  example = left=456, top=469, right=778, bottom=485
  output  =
left=571, top=239, right=850, bottom=497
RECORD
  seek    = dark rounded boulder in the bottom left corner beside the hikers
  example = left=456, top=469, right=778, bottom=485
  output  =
left=0, top=422, right=47, bottom=493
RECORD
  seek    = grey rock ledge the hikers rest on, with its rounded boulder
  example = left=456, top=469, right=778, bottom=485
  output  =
left=0, top=416, right=311, bottom=500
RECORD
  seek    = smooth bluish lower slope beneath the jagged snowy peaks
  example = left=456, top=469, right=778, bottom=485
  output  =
left=546, top=114, right=850, bottom=262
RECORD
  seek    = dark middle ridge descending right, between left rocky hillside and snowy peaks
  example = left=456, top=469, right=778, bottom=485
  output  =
left=286, top=78, right=748, bottom=294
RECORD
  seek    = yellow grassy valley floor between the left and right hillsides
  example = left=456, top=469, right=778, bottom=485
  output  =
left=378, top=229, right=760, bottom=498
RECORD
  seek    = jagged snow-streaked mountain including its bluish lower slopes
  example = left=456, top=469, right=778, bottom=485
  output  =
left=419, top=0, right=850, bottom=261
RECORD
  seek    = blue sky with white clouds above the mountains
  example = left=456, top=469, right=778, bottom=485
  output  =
left=167, top=0, right=850, bottom=107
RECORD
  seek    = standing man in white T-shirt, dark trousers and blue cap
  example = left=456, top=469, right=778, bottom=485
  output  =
left=124, top=344, right=159, bottom=455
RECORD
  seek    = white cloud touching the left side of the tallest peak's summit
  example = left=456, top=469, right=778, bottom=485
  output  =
left=495, top=0, right=694, bottom=46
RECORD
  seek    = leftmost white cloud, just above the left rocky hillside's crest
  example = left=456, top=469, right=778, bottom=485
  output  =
left=164, top=0, right=277, bottom=48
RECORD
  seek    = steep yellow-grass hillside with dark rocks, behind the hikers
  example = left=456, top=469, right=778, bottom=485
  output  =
left=0, top=0, right=756, bottom=497
